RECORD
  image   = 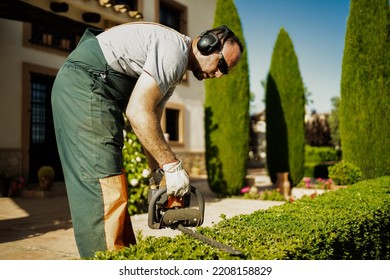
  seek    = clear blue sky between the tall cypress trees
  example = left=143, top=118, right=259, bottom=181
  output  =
left=234, top=0, right=349, bottom=113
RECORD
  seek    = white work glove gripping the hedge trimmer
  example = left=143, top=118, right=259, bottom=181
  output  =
left=163, top=160, right=191, bottom=196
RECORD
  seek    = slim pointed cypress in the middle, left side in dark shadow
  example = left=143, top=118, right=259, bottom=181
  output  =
left=265, top=28, right=305, bottom=185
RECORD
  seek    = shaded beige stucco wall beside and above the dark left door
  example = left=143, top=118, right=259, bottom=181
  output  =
left=0, top=18, right=65, bottom=149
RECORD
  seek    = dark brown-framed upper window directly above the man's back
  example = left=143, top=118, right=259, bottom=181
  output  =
left=160, top=0, right=187, bottom=34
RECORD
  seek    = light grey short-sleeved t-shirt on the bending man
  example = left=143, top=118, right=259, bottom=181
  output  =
left=97, top=22, right=191, bottom=97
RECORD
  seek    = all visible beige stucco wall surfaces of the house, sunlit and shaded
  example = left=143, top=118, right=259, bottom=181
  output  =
left=0, top=0, right=216, bottom=155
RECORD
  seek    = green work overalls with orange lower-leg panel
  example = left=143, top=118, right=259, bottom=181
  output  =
left=52, top=29, right=136, bottom=258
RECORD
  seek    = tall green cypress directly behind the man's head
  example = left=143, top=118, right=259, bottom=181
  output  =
left=205, top=0, right=250, bottom=196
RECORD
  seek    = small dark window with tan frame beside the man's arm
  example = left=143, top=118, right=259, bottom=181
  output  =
left=162, top=103, right=184, bottom=145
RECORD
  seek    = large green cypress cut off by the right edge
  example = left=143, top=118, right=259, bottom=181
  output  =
left=340, top=0, right=390, bottom=178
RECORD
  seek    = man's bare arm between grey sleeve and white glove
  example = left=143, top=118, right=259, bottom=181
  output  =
left=126, top=72, right=177, bottom=170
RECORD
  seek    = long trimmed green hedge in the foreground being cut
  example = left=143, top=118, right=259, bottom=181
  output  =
left=95, top=176, right=390, bottom=260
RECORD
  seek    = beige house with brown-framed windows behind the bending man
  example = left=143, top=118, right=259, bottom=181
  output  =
left=0, top=0, right=216, bottom=182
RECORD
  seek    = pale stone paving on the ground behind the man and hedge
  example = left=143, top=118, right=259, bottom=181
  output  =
left=0, top=167, right=310, bottom=260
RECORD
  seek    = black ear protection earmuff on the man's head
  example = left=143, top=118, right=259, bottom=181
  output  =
left=197, top=25, right=233, bottom=55
